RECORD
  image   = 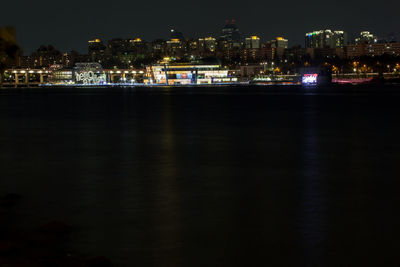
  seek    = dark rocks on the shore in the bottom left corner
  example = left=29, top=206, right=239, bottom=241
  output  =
left=0, top=194, right=113, bottom=267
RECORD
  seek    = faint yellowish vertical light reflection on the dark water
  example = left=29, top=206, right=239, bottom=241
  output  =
left=153, top=96, right=185, bottom=266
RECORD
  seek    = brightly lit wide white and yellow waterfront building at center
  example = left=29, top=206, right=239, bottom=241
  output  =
left=146, top=64, right=237, bottom=85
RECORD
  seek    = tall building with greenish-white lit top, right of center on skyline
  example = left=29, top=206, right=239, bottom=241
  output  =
left=305, top=30, right=347, bottom=48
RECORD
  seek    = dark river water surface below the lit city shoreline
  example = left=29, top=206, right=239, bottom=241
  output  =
left=0, top=86, right=400, bottom=267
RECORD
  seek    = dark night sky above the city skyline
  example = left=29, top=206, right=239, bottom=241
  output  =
left=0, top=0, right=400, bottom=54
